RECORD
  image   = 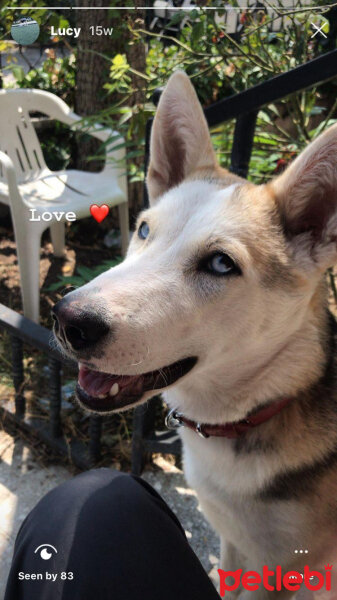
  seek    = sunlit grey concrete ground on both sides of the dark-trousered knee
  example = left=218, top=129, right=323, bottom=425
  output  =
left=0, top=431, right=219, bottom=599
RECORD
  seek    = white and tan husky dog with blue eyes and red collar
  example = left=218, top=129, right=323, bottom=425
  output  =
left=54, top=72, right=337, bottom=600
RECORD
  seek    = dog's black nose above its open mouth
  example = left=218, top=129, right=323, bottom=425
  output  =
left=52, top=296, right=110, bottom=351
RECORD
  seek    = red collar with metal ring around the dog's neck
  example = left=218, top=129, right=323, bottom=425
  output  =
left=165, top=398, right=290, bottom=438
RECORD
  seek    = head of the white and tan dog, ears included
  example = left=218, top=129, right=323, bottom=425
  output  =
left=54, top=72, right=337, bottom=423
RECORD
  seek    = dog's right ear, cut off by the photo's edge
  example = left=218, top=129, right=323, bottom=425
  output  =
left=270, top=125, right=337, bottom=268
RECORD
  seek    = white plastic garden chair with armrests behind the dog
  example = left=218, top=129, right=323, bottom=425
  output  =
left=0, top=89, right=129, bottom=322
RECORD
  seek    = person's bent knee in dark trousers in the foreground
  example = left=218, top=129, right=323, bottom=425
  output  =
left=5, top=469, right=219, bottom=600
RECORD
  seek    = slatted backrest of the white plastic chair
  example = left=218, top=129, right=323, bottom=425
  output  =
left=0, top=89, right=58, bottom=183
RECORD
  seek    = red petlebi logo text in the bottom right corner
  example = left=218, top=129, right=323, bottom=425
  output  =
left=218, top=565, right=332, bottom=596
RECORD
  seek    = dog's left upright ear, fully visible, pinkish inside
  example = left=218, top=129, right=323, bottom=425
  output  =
left=147, top=71, right=216, bottom=203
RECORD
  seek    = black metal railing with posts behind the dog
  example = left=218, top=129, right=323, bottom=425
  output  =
left=0, top=50, right=337, bottom=474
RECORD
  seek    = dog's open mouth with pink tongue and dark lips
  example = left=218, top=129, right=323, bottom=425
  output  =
left=76, top=357, right=197, bottom=413
